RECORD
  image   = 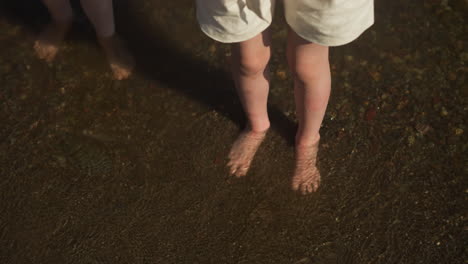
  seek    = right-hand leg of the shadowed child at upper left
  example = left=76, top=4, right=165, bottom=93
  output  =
left=81, top=0, right=134, bottom=80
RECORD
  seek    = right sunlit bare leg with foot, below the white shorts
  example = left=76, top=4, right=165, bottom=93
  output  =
left=288, top=30, right=331, bottom=193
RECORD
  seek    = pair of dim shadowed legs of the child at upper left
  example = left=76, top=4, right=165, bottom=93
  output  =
left=34, top=0, right=134, bottom=80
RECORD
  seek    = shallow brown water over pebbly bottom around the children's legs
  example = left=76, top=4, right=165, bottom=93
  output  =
left=0, top=0, right=468, bottom=263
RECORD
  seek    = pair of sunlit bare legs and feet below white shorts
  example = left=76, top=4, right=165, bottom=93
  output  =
left=228, top=29, right=331, bottom=194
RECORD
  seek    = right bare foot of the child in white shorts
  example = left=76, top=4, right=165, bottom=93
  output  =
left=292, top=138, right=320, bottom=194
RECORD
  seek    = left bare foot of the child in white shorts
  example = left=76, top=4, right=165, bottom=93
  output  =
left=227, top=128, right=267, bottom=177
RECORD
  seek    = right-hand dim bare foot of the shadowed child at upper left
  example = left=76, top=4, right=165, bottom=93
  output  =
left=98, top=34, right=135, bottom=80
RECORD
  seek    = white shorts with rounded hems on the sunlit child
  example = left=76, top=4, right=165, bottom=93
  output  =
left=197, top=0, right=374, bottom=46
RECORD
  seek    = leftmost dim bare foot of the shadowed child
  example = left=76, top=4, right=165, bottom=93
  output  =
left=34, top=21, right=71, bottom=62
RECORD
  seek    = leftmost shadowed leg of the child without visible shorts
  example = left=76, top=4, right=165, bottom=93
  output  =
left=34, top=0, right=73, bottom=62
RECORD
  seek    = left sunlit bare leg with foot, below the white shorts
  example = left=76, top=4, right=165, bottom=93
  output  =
left=228, top=30, right=271, bottom=177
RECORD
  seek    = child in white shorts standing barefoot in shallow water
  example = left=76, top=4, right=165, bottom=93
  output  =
left=196, top=0, right=374, bottom=194
